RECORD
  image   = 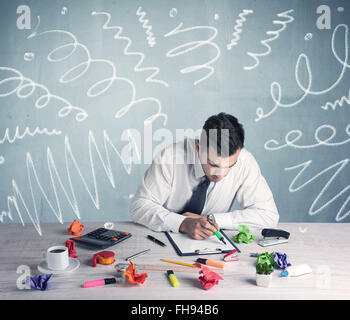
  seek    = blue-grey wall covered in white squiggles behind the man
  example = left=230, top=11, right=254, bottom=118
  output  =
left=0, top=0, right=350, bottom=232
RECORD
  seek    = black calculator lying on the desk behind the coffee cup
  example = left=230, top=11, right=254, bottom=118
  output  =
left=71, top=228, right=131, bottom=250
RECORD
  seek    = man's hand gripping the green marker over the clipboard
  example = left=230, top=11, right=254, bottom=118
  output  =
left=179, top=212, right=219, bottom=240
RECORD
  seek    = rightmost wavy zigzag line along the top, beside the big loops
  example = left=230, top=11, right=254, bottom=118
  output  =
left=243, top=9, right=294, bottom=70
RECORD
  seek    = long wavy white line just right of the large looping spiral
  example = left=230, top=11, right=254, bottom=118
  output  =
left=91, top=11, right=169, bottom=87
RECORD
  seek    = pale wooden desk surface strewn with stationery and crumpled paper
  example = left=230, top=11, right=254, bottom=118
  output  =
left=0, top=222, right=350, bottom=300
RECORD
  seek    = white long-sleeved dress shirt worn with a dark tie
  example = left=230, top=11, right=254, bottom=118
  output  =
left=130, top=139, right=279, bottom=232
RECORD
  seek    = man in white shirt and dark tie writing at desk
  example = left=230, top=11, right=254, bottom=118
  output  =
left=130, top=113, right=279, bottom=239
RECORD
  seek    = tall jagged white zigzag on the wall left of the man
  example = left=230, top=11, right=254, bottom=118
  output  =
left=0, top=130, right=139, bottom=236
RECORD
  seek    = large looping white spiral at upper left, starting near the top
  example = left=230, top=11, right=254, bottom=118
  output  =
left=31, top=13, right=168, bottom=125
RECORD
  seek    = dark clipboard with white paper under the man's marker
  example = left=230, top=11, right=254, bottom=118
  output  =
left=165, top=230, right=241, bottom=256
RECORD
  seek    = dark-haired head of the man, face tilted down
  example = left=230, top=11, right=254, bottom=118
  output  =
left=196, top=112, right=244, bottom=182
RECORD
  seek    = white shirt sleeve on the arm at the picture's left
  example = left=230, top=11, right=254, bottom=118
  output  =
left=130, top=149, right=186, bottom=232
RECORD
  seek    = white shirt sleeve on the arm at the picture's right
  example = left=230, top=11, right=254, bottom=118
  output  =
left=214, top=153, right=279, bottom=230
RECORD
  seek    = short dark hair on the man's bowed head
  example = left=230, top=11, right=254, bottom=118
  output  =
left=201, top=112, right=244, bottom=156
